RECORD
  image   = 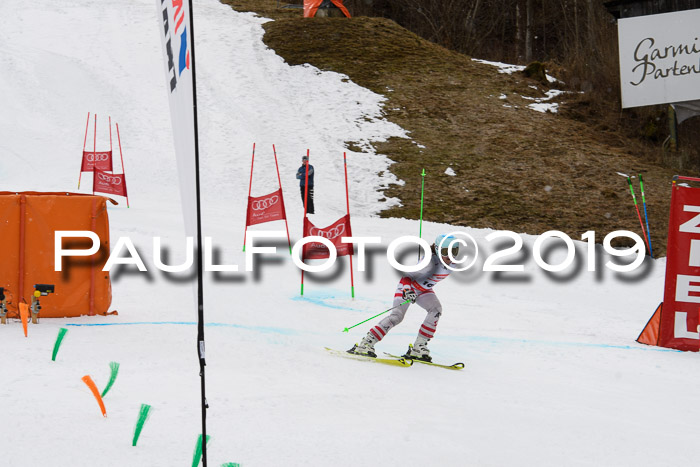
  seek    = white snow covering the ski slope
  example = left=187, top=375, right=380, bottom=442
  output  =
left=0, top=0, right=700, bottom=467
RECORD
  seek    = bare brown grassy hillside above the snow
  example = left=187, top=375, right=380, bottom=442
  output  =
left=222, top=0, right=691, bottom=256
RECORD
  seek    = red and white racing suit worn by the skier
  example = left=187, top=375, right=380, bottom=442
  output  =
left=369, top=252, right=452, bottom=341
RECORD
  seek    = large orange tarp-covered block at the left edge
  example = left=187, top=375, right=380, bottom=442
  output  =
left=0, top=192, right=116, bottom=318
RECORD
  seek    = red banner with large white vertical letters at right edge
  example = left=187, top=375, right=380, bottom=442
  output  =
left=659, top=183, right=700, bottom=351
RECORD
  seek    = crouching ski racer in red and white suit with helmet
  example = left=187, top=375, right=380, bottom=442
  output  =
left=348, top=235, right=459, bottom=362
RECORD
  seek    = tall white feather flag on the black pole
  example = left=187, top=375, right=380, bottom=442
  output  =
left=156, top=0, right=199, bottom=239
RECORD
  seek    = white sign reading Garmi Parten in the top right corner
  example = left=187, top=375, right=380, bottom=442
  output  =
left=618, top=9, right=700, bottom=108
